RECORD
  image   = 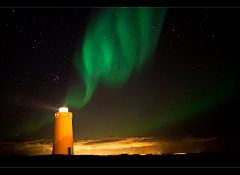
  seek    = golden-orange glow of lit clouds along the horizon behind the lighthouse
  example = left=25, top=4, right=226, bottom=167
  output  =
left=0, top=135, right=219, bottom=156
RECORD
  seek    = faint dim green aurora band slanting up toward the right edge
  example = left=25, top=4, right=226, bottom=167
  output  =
left=116, top=77, right=239, bottom=135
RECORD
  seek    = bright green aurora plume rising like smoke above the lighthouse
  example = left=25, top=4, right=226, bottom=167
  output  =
left=65, top=8, right=166, bottom=109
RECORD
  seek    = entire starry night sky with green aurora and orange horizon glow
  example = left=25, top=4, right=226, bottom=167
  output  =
left=0, top=8, right=240, bottom=155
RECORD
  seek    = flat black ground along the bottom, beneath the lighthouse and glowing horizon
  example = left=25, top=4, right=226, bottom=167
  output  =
left=0, top=152, right=240, bottom=167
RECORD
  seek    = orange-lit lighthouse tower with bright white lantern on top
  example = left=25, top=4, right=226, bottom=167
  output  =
left=52, top=104, right=73, bottom=155
